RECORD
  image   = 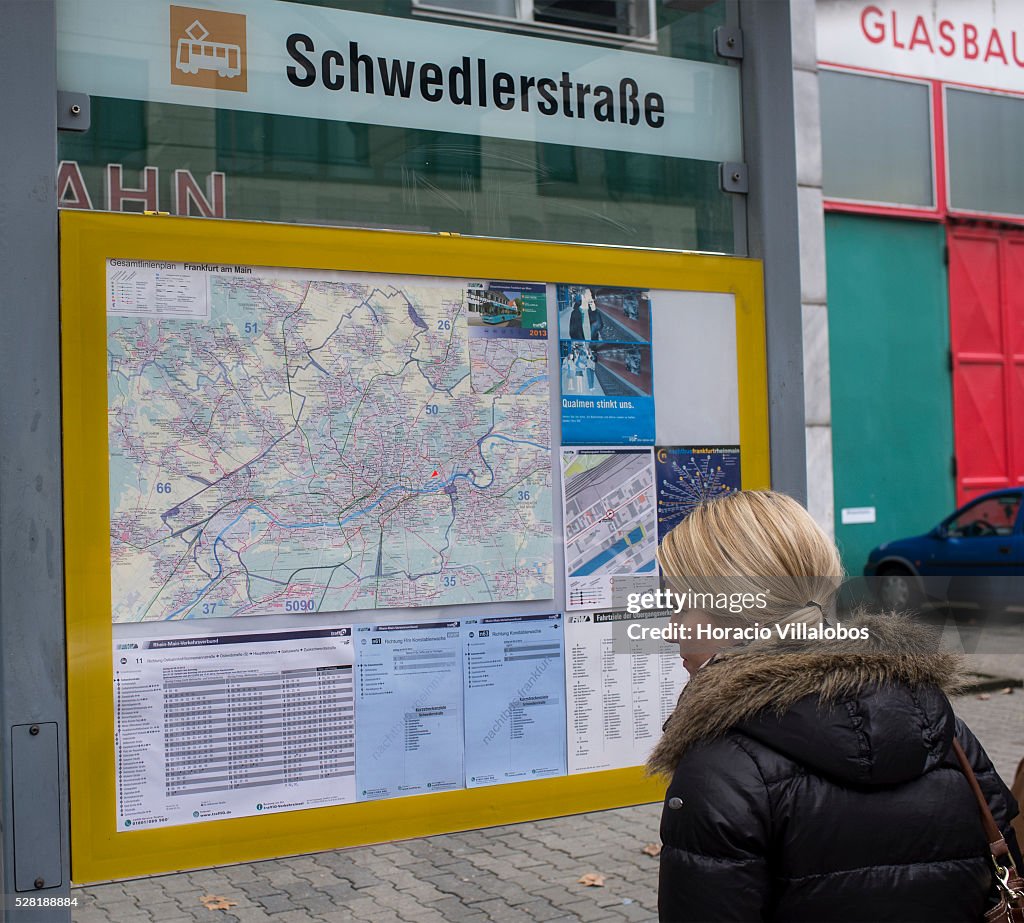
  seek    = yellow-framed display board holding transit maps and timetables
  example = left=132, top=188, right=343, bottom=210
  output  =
left=61, top=213, right=767, bottom=881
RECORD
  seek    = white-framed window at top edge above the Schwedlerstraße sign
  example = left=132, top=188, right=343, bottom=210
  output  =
left=413, top=0, right=655, bottom=42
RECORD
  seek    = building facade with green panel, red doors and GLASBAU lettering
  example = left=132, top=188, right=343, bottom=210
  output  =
left=794, top=0, right=1024, bottom=574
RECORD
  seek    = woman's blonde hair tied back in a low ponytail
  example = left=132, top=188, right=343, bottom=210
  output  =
left=657, top=491, right=843, bottom=624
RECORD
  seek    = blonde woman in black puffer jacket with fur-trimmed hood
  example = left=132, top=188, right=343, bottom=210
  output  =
left=649, top=491, right=1019, bottom=923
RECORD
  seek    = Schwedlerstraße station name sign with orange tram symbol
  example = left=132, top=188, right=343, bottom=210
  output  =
left=57, top=0, right=741, bottom=161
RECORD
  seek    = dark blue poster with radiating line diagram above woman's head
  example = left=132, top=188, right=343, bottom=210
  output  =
left=654, top=446, right=740, bottom=543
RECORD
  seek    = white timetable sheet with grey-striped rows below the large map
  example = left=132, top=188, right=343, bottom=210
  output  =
left=114, top=627, right=355, bottom=832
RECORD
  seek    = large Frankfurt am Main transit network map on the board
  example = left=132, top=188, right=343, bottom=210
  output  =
left=106, top=259, right=554, bottom=622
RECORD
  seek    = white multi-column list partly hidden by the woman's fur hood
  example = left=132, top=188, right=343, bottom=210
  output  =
left=565, top=612, right=688, bottom=772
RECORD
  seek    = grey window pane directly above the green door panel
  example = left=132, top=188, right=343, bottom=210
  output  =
left=818, top=71, right=935, bottom=208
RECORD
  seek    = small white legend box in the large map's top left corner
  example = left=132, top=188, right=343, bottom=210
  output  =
left=106, top=259, right=209, bottom=321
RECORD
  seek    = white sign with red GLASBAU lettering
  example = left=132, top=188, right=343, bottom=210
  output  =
left=817, top=0, right=1024, bottom=91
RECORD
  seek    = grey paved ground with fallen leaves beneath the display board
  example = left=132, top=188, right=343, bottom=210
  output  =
left=72, top=617, right=1024, bottom=923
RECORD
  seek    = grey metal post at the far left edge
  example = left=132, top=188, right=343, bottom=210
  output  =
left=0, top=0, right=71, bottom=923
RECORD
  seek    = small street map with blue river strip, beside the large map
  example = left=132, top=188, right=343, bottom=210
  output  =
left=562, top=449, right=657, bottom=609
